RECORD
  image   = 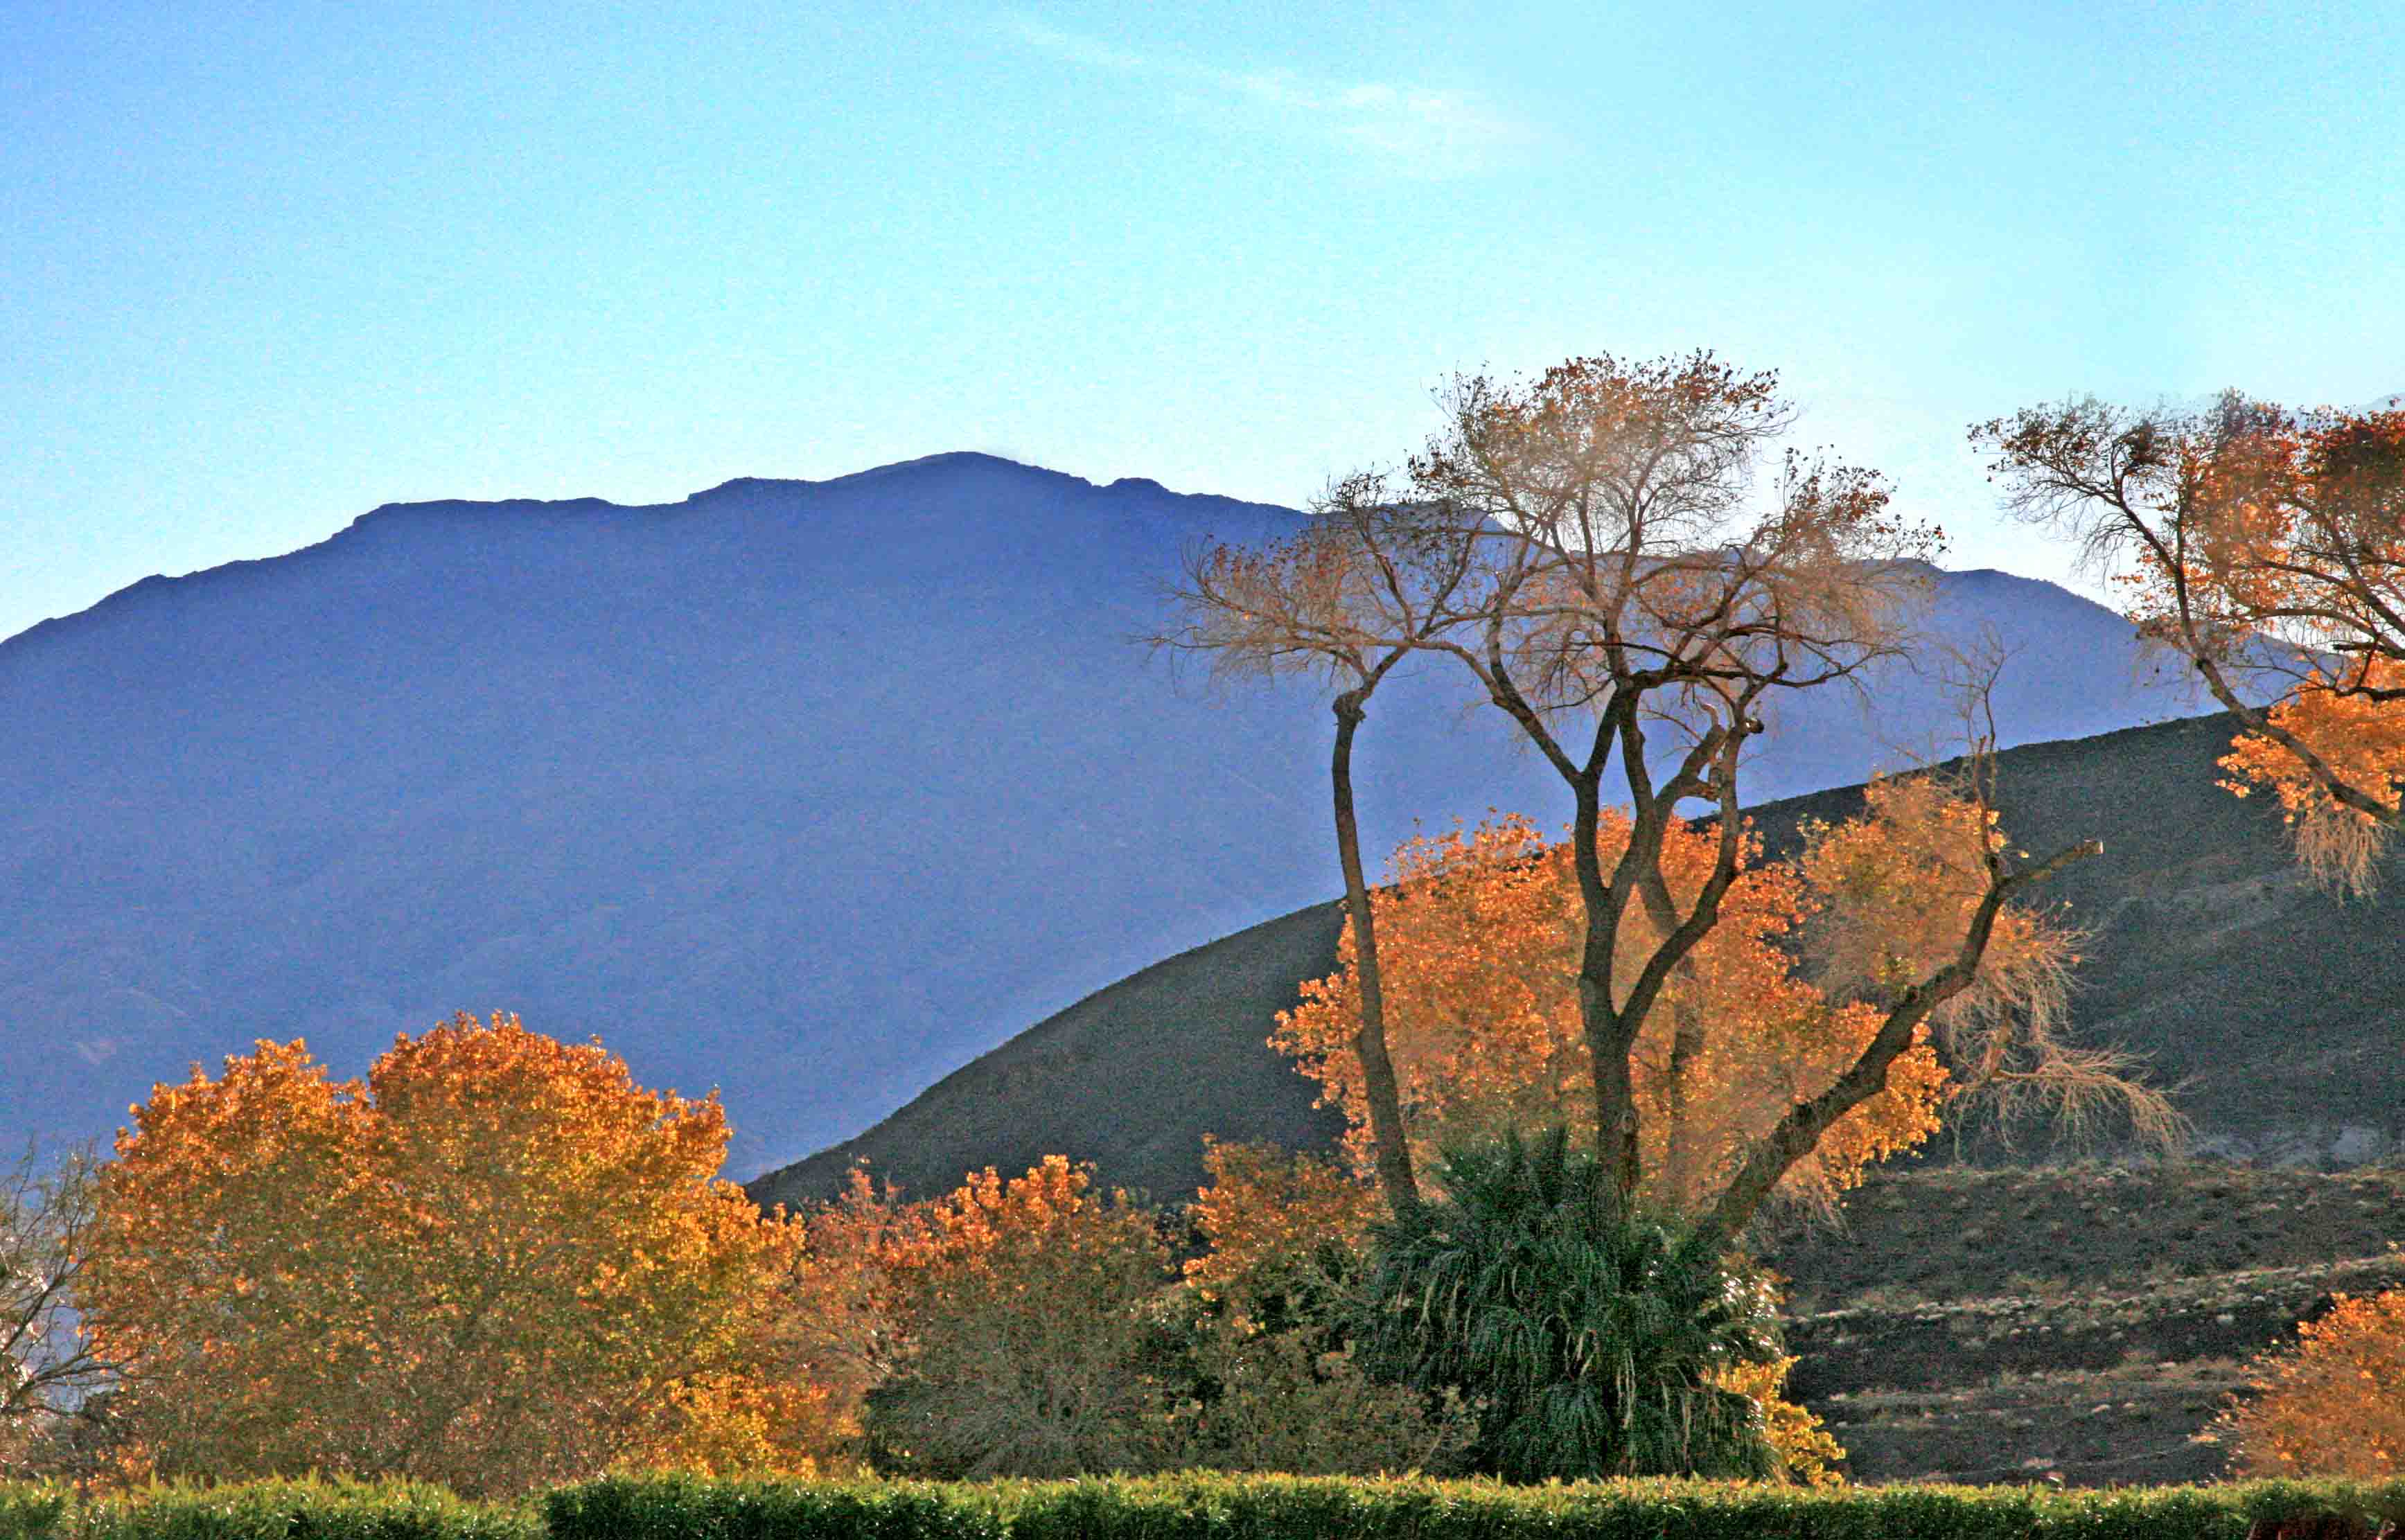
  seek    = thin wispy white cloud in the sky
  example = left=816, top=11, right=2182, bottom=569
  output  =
left=1003, top=15, right=1537, bottom=178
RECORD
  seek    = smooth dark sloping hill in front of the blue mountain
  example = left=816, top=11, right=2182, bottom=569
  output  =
left=752, top=717, right=2405, bottom=1201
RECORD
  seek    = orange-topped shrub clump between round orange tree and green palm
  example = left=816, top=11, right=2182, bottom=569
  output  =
left=786, top=1143, right=1467, bottom=1478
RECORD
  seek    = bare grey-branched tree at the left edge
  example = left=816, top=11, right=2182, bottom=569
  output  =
left=0, top=1143, right=116, bottom=1478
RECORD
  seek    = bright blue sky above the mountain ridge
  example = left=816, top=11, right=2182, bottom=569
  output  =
left=0, top=0, right=2405, bottom=635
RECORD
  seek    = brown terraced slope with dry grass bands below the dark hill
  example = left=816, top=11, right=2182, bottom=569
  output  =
left=1770, top=1162, right=2405, bottom=1485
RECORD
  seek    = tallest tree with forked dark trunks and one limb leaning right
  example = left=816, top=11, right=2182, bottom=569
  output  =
left=1260, top=354, right=2126, bottom=1237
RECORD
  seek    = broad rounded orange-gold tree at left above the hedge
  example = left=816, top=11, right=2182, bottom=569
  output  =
left=84, top=1013, right=811, bottom=1494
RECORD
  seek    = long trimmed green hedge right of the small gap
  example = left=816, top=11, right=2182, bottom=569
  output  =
left=543, top=1475, right=2405, bottom=1540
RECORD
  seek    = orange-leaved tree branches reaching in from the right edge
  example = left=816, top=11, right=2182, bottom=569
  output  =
left=1972, top=392, right=2405, bottom=893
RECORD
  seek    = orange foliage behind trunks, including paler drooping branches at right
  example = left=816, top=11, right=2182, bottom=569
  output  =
left=1272, top=777, right=2176, bottom=1213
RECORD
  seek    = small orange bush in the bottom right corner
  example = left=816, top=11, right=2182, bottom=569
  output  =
left=2203, top=1290, right=2405, bottom=1480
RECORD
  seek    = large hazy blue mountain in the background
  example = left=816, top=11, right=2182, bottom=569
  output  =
left=0, top=454, right=2198, bottom=1174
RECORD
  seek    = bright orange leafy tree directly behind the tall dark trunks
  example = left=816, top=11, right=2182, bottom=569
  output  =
left=1270, top=811, right=1946, bottom=1208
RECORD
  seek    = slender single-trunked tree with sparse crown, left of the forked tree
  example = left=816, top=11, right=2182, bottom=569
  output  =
left=1147, top=474, right=1481, bottom=1213
